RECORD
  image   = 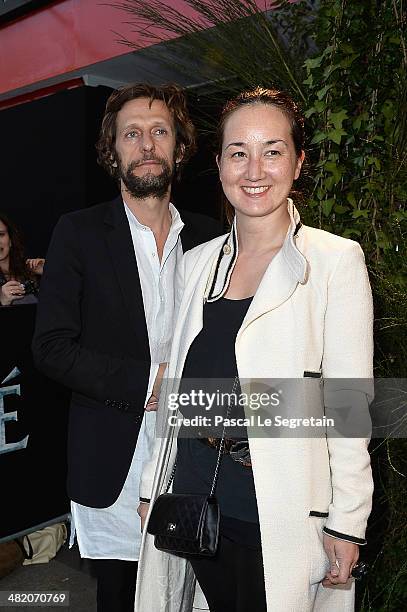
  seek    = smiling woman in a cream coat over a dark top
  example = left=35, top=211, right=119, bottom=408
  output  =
left=136, top=88, right=373, bottom=612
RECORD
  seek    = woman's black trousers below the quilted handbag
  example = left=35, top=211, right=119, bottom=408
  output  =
left=190, top=537, right=267, bottom=612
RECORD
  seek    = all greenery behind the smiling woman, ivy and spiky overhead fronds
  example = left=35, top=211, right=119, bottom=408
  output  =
left=116, top=0, right=407, bottom=612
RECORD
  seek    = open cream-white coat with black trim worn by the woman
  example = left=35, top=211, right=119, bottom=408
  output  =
left=135, top=200, right=373, bottom=612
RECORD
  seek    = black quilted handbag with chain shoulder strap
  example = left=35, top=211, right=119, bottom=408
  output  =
left=147, top=377, right=239, bottom=557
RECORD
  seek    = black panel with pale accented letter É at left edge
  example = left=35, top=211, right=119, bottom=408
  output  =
left=0, top=304, right=70, bottom=539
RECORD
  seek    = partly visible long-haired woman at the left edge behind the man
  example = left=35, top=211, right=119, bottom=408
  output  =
left=0, top=213, right=45, bottom=306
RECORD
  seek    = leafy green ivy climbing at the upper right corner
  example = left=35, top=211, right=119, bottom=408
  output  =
left=303, top=0, right=407, bottom=260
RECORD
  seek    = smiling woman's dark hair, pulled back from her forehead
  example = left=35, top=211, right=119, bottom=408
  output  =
left=216, top=87, right=305, bottom=223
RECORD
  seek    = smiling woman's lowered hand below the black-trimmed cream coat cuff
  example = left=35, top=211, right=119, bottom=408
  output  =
left=322, top=534, right=359, bottom=587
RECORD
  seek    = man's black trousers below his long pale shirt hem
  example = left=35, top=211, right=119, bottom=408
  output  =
left=92, top=559, right=138, bottom=612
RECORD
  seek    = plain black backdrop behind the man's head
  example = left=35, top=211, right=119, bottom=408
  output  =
left=0, top=87, right=220, bottom=257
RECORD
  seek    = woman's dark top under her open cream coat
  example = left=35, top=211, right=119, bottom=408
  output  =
left=173, top=298, right=260, bottom=548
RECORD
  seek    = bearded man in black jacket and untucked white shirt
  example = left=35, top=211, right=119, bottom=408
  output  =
left=33, top=84, right=219, bottom=612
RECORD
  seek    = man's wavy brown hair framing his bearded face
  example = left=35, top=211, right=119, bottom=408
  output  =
left=96, top=83, right=196, bottom=179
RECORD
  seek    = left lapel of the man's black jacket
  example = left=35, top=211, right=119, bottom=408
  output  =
left=104, top=197, right=150, bottom=353
